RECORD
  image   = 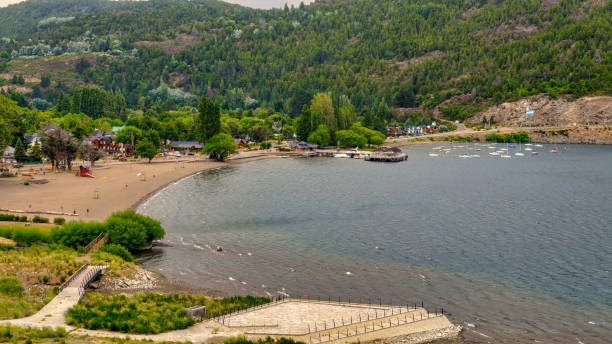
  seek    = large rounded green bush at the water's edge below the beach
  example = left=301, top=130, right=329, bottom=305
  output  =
left=105, top=210, right=166, bottom=251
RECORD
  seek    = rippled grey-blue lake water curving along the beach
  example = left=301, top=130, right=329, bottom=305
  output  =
left=138, top=144, right=612, bottom=343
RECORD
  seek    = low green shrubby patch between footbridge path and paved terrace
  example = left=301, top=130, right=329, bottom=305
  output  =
left=67, top=293, right=270, bottom=334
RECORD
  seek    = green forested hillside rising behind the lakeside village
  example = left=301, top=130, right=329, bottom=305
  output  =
left=0, top=0, right=612, bottom=120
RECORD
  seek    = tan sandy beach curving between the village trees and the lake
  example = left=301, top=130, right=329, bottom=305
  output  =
left=0, top=157, right=227, bottom=221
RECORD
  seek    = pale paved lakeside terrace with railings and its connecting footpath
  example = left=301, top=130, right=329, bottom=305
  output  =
left=0, top=266, right=461, bottom=344
